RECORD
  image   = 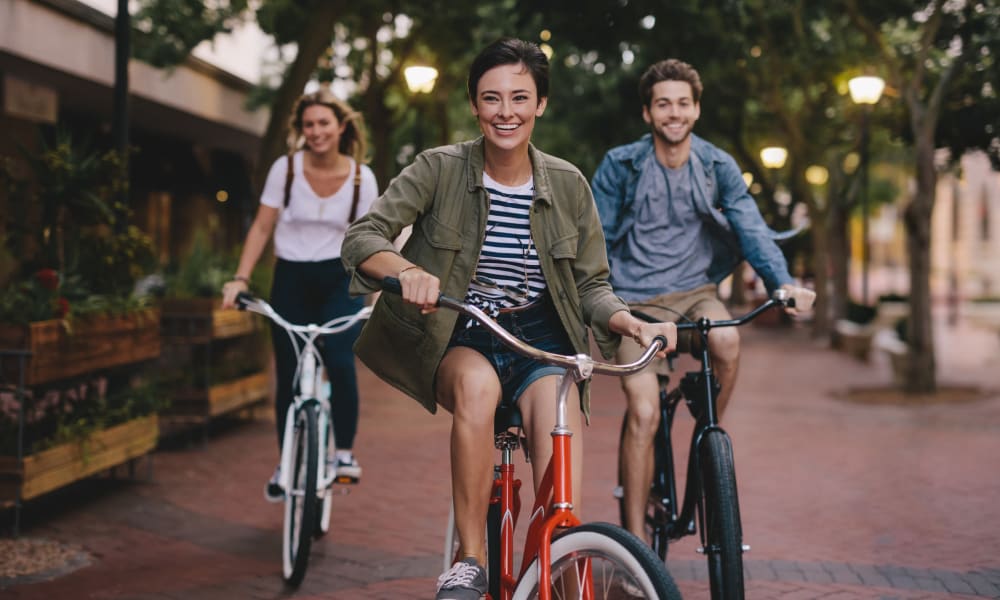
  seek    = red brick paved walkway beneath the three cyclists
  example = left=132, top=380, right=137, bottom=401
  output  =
left=0, top=312, right=1000, bottom=600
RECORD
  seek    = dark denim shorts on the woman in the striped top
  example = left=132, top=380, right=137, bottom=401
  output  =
left=448, top=295, right=576, bottom=404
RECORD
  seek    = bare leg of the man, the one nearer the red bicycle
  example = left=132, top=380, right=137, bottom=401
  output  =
left=619, top=369, right=660, bottom=542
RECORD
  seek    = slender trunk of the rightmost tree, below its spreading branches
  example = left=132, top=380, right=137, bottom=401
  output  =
left=903, top=135, right=937, bottom=394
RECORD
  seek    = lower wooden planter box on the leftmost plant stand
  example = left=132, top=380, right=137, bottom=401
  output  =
left=0, top=415, right=159, bottom=503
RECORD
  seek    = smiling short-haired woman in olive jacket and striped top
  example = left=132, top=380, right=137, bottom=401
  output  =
left=342, top=39, right=676, bottom=600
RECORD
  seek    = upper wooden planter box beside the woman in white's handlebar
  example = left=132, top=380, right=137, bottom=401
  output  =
left=160, top=298, right=258, bottom=344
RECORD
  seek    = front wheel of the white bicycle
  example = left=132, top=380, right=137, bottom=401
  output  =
left=282, top=402, right=319, bottom=586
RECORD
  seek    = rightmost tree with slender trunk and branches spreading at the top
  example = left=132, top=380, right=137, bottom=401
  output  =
left=845, top=0, right=1000, bottom=393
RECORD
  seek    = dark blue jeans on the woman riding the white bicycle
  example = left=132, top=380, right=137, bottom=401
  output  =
left=271, top=258, right=364, bottom=448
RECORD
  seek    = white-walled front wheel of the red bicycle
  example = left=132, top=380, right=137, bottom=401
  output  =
left=514, top=523, right=681, bottom=600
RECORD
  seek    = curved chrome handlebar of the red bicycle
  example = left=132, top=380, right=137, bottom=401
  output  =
left=382, top=277, right=667, bottom=379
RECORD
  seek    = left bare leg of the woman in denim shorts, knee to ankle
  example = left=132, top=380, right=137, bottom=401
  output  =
left=437, top=347, right=500, bottom=564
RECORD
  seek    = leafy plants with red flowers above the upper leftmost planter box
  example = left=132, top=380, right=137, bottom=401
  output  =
left=0, top=131, right=155, bottom=324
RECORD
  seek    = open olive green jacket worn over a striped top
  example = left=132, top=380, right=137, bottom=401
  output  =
left=341, top=138, right=628, bottom=413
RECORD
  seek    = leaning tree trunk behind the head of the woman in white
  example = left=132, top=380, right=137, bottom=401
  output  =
left=253, top=0, right=343, bottom=196
